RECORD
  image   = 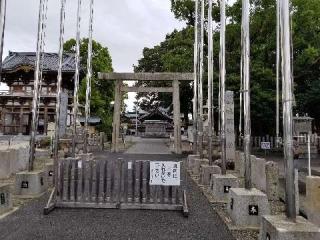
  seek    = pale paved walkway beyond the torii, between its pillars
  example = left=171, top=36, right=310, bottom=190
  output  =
left=126, top=138, right=171, bottom=154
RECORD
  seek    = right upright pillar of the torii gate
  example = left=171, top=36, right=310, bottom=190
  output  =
left=172, top=80, right=182, bottom=154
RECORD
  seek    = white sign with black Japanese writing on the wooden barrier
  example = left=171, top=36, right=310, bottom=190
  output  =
left=150, top=161, right=180, bottom=186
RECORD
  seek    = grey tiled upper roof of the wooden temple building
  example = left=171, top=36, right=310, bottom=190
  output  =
left=2, top=52, right=75, bottom=72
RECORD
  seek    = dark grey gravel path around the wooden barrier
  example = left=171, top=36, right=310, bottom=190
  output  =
left=0, top=153, right=234, bottom=240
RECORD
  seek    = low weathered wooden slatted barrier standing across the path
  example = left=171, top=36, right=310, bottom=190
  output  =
left=45, top=158, right=188, bottom=216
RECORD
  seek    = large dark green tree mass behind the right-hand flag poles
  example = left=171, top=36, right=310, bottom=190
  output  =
left=135, top=0, right=320, bottom=135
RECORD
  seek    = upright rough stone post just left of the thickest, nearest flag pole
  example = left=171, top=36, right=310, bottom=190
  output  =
left=266, top=162, right=279, bottom=201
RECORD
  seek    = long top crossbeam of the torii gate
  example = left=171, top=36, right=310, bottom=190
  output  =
left=98, top=73, right=194, bottom=81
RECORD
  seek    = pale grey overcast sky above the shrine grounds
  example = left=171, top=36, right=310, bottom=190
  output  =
left=4, top=0, right=184, bottom=108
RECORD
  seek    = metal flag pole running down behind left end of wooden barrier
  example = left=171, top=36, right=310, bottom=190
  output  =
left=53, top=0, right=66, bottom=188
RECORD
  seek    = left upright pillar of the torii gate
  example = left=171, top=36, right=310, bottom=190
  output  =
left=111, top=80, right=122, bottom=152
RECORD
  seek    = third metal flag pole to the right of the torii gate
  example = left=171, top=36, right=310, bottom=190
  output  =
left=208, top=0, right=213, bottom=165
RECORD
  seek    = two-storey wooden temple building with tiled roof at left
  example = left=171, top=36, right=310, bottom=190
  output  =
left=0, top=52, right=75, bottom=135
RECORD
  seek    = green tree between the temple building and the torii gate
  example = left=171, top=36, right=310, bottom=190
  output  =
left=64, top=38, right=114, bottom=135
